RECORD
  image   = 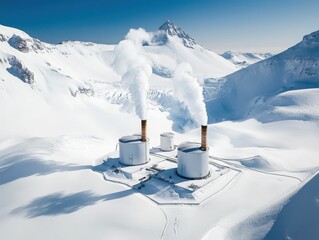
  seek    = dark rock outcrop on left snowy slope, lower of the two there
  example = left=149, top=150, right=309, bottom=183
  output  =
left=7, top=57, right=34, bottom=84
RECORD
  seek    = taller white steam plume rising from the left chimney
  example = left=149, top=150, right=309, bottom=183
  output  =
left=113, top=28, right=152, bottom=119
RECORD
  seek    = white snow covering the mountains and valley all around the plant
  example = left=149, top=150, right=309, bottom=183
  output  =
left=0, top=23, right=319, bottom=240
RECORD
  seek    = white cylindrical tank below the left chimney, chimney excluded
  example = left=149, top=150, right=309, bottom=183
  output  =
left=119, top=135, right=149, bottom=165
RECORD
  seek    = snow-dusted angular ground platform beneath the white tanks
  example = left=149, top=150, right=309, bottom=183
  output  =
left=93, top=148, right=240, bottom=205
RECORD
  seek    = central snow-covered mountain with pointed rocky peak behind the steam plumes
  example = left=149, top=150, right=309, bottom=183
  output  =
left=146, top=20, right=236, bottom=78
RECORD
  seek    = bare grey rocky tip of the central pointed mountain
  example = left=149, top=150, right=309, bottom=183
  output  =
left=159, top=20, right=196, bottom=48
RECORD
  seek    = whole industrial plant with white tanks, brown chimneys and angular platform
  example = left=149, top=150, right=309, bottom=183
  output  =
left=95, top=120, right=240, bottom=204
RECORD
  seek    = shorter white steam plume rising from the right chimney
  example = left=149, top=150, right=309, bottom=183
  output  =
left=173, top=63, right=207, bottom=125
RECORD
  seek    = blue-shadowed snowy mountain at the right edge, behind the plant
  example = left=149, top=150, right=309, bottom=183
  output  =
left=208, top=32, right=319, bottom=120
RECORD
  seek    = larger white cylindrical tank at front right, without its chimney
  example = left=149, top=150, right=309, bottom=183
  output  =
left=177, top=142, right=209, bottom=179
